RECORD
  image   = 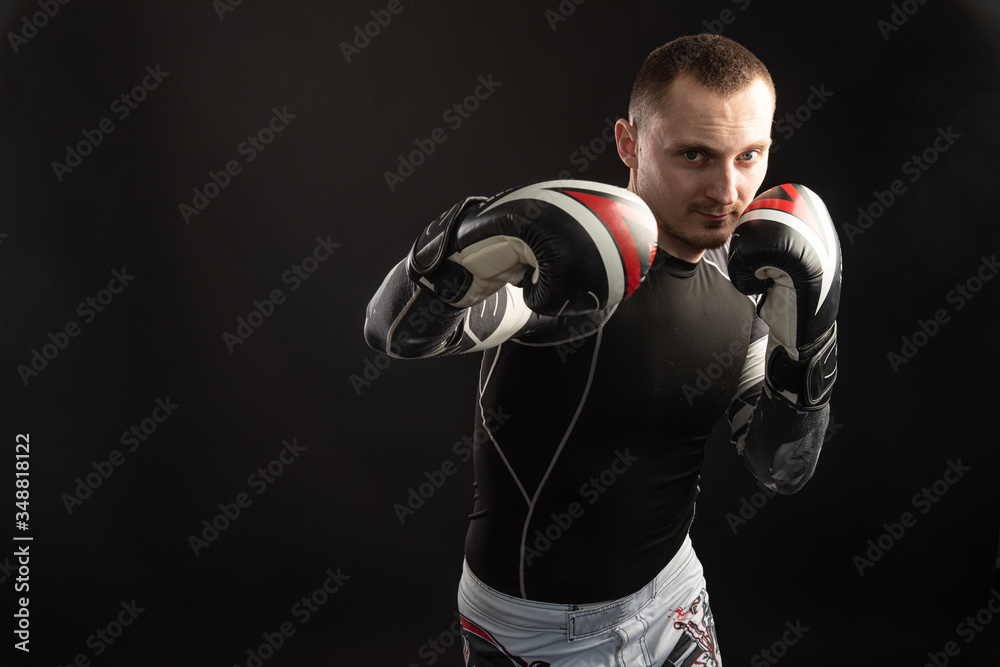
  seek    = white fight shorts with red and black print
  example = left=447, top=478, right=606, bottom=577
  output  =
left=458, top=537, right=722, bottom=667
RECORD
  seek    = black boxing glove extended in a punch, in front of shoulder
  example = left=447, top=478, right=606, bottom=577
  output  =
left=407, top=180, right=657, bottom=316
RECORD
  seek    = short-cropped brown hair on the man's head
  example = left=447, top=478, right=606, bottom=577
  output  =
left=628, top=33, right=774, bottom=127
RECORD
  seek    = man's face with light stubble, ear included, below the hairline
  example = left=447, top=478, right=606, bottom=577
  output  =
left=618, top=76, right=774, bottom=261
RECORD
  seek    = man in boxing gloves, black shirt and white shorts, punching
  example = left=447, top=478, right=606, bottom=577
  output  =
left=366, top=35, right=840, bottom=667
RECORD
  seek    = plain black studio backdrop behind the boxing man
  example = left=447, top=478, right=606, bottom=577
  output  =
left=0, top=0, right=1000, bottom=667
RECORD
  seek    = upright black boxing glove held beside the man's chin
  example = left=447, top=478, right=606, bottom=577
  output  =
left=729, top=184, right=841, bottom=410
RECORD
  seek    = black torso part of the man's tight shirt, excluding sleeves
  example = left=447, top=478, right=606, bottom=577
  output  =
left=466, top=250, right=765, bottom=602
